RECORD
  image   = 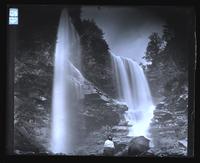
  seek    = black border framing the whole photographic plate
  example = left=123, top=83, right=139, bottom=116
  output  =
left=0, top=0, right=200, bottom=162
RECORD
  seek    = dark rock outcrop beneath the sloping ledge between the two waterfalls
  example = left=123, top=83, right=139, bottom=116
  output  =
left=74, top=80, right=128, bottom=138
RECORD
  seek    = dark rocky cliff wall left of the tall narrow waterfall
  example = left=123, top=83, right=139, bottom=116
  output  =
left=14, top=11, right=58, bottom=154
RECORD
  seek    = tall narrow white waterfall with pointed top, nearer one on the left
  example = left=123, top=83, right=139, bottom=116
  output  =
left=50, top=9, right=83, bottom=154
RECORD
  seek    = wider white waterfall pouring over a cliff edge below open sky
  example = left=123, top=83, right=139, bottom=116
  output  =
left=112, top=55, right=155, bottom=137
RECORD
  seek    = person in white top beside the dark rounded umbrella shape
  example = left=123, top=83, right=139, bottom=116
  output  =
left=103, top=135, right=115, bottom=156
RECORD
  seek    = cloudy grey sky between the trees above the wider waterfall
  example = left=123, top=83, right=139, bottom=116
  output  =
left=82, top=6, right=165, bottom=63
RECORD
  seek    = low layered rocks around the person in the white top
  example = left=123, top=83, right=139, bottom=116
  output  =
left=74, top=114, right=131, bottom=156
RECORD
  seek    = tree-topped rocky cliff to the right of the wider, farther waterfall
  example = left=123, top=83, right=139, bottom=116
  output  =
left=144, top=9, right=194, bottom=155
